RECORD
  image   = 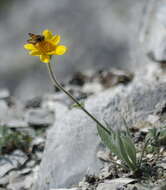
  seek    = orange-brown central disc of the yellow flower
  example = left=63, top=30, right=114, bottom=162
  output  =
left=35, top=41, right=55, bottom=53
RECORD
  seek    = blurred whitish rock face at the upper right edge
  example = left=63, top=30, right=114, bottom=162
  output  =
left=145, top=0, right=166, bottom=61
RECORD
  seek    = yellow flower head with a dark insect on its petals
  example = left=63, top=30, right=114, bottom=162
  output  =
left=24, top=30, right=67, bottom=63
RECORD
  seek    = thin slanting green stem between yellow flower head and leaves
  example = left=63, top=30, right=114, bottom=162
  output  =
left=47, top=63, right=110, bottom=134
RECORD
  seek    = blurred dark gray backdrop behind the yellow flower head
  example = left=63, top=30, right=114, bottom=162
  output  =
left=0, top=0, right=148, bottom=99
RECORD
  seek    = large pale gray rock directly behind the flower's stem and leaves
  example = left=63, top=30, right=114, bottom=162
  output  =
left=35, top=76, right=166, bottom=190
